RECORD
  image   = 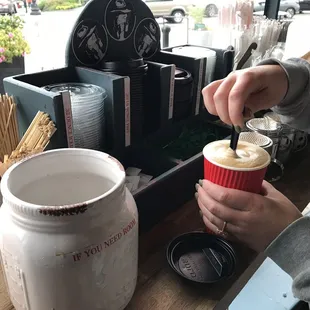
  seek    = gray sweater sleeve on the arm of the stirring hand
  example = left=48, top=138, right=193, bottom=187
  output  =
left=259, top=58, right=310, bottom=133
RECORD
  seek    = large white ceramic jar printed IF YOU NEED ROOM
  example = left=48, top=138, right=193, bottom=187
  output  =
left=0, top=149, right=138, bottom=310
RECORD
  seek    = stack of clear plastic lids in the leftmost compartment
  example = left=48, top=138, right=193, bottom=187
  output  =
left=44, top=83, right=106, bottom=150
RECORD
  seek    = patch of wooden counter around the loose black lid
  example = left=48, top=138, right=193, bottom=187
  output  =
left=126, top=201, right=256, bottom=310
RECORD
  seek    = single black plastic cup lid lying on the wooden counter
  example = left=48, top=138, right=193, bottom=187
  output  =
left=166, top=232, right=237, bottom=283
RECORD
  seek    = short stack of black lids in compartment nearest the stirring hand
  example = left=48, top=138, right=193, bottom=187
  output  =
left=173, top=68, right=194, bottom=121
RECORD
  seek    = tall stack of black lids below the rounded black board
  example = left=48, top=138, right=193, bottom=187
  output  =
left=102, top=59, right=148, bottom=144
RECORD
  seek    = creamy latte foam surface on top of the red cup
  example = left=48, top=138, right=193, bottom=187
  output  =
left=203, top=140, right=270, bottom=170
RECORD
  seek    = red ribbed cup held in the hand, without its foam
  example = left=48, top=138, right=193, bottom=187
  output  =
left=203, top=140, right=270, bottom=194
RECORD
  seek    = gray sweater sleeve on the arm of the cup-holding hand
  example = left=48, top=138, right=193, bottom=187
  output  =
left=266, top=216, right=310, bottom=304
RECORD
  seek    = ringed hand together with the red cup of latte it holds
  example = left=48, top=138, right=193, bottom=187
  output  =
left=196, top=140, right=301, bottom=251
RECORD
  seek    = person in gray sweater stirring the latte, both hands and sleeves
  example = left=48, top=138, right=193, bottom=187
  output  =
left=196, top=59, right=310, bottom=303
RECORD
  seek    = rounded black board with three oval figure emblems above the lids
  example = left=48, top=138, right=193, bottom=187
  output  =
left=66, top=0, right=160, bottom=69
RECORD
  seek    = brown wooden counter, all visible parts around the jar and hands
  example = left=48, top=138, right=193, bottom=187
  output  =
left=0, top=147, right=310, bottom=310
